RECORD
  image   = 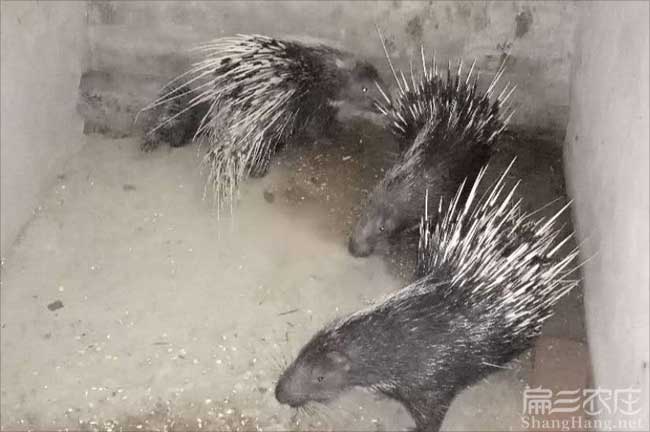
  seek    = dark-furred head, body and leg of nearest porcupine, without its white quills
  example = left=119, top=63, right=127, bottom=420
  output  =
left=276, top=279, right=531, bottom=431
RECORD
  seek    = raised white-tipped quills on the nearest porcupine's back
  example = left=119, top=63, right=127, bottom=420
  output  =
left=405, top=161, right=578, bottom=339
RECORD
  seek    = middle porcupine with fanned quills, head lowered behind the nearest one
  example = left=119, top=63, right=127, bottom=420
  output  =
left=348, top=39, right=514, bottom=257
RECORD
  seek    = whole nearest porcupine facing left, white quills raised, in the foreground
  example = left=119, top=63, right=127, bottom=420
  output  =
left=275, top=161, right=578, bottom=432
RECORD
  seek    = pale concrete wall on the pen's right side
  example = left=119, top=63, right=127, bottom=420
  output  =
left=565, top=2, right=650, bottom=430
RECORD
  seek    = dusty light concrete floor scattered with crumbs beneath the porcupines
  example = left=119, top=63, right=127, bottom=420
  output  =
left=0, top=120, right=584, bottom=430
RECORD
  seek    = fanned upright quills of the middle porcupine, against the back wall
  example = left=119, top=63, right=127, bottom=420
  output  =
left=375, top=43, right=516, bottom=191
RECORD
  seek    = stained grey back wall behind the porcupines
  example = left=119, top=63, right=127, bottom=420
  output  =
left=83, top=1, right=575, bottom=141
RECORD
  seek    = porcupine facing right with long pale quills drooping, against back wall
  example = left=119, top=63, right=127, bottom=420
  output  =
left=139, top=35, right=378, bottom=211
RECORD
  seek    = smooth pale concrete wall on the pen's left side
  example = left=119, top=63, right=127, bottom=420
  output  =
left=0, top=1, right=87, bottom=256
